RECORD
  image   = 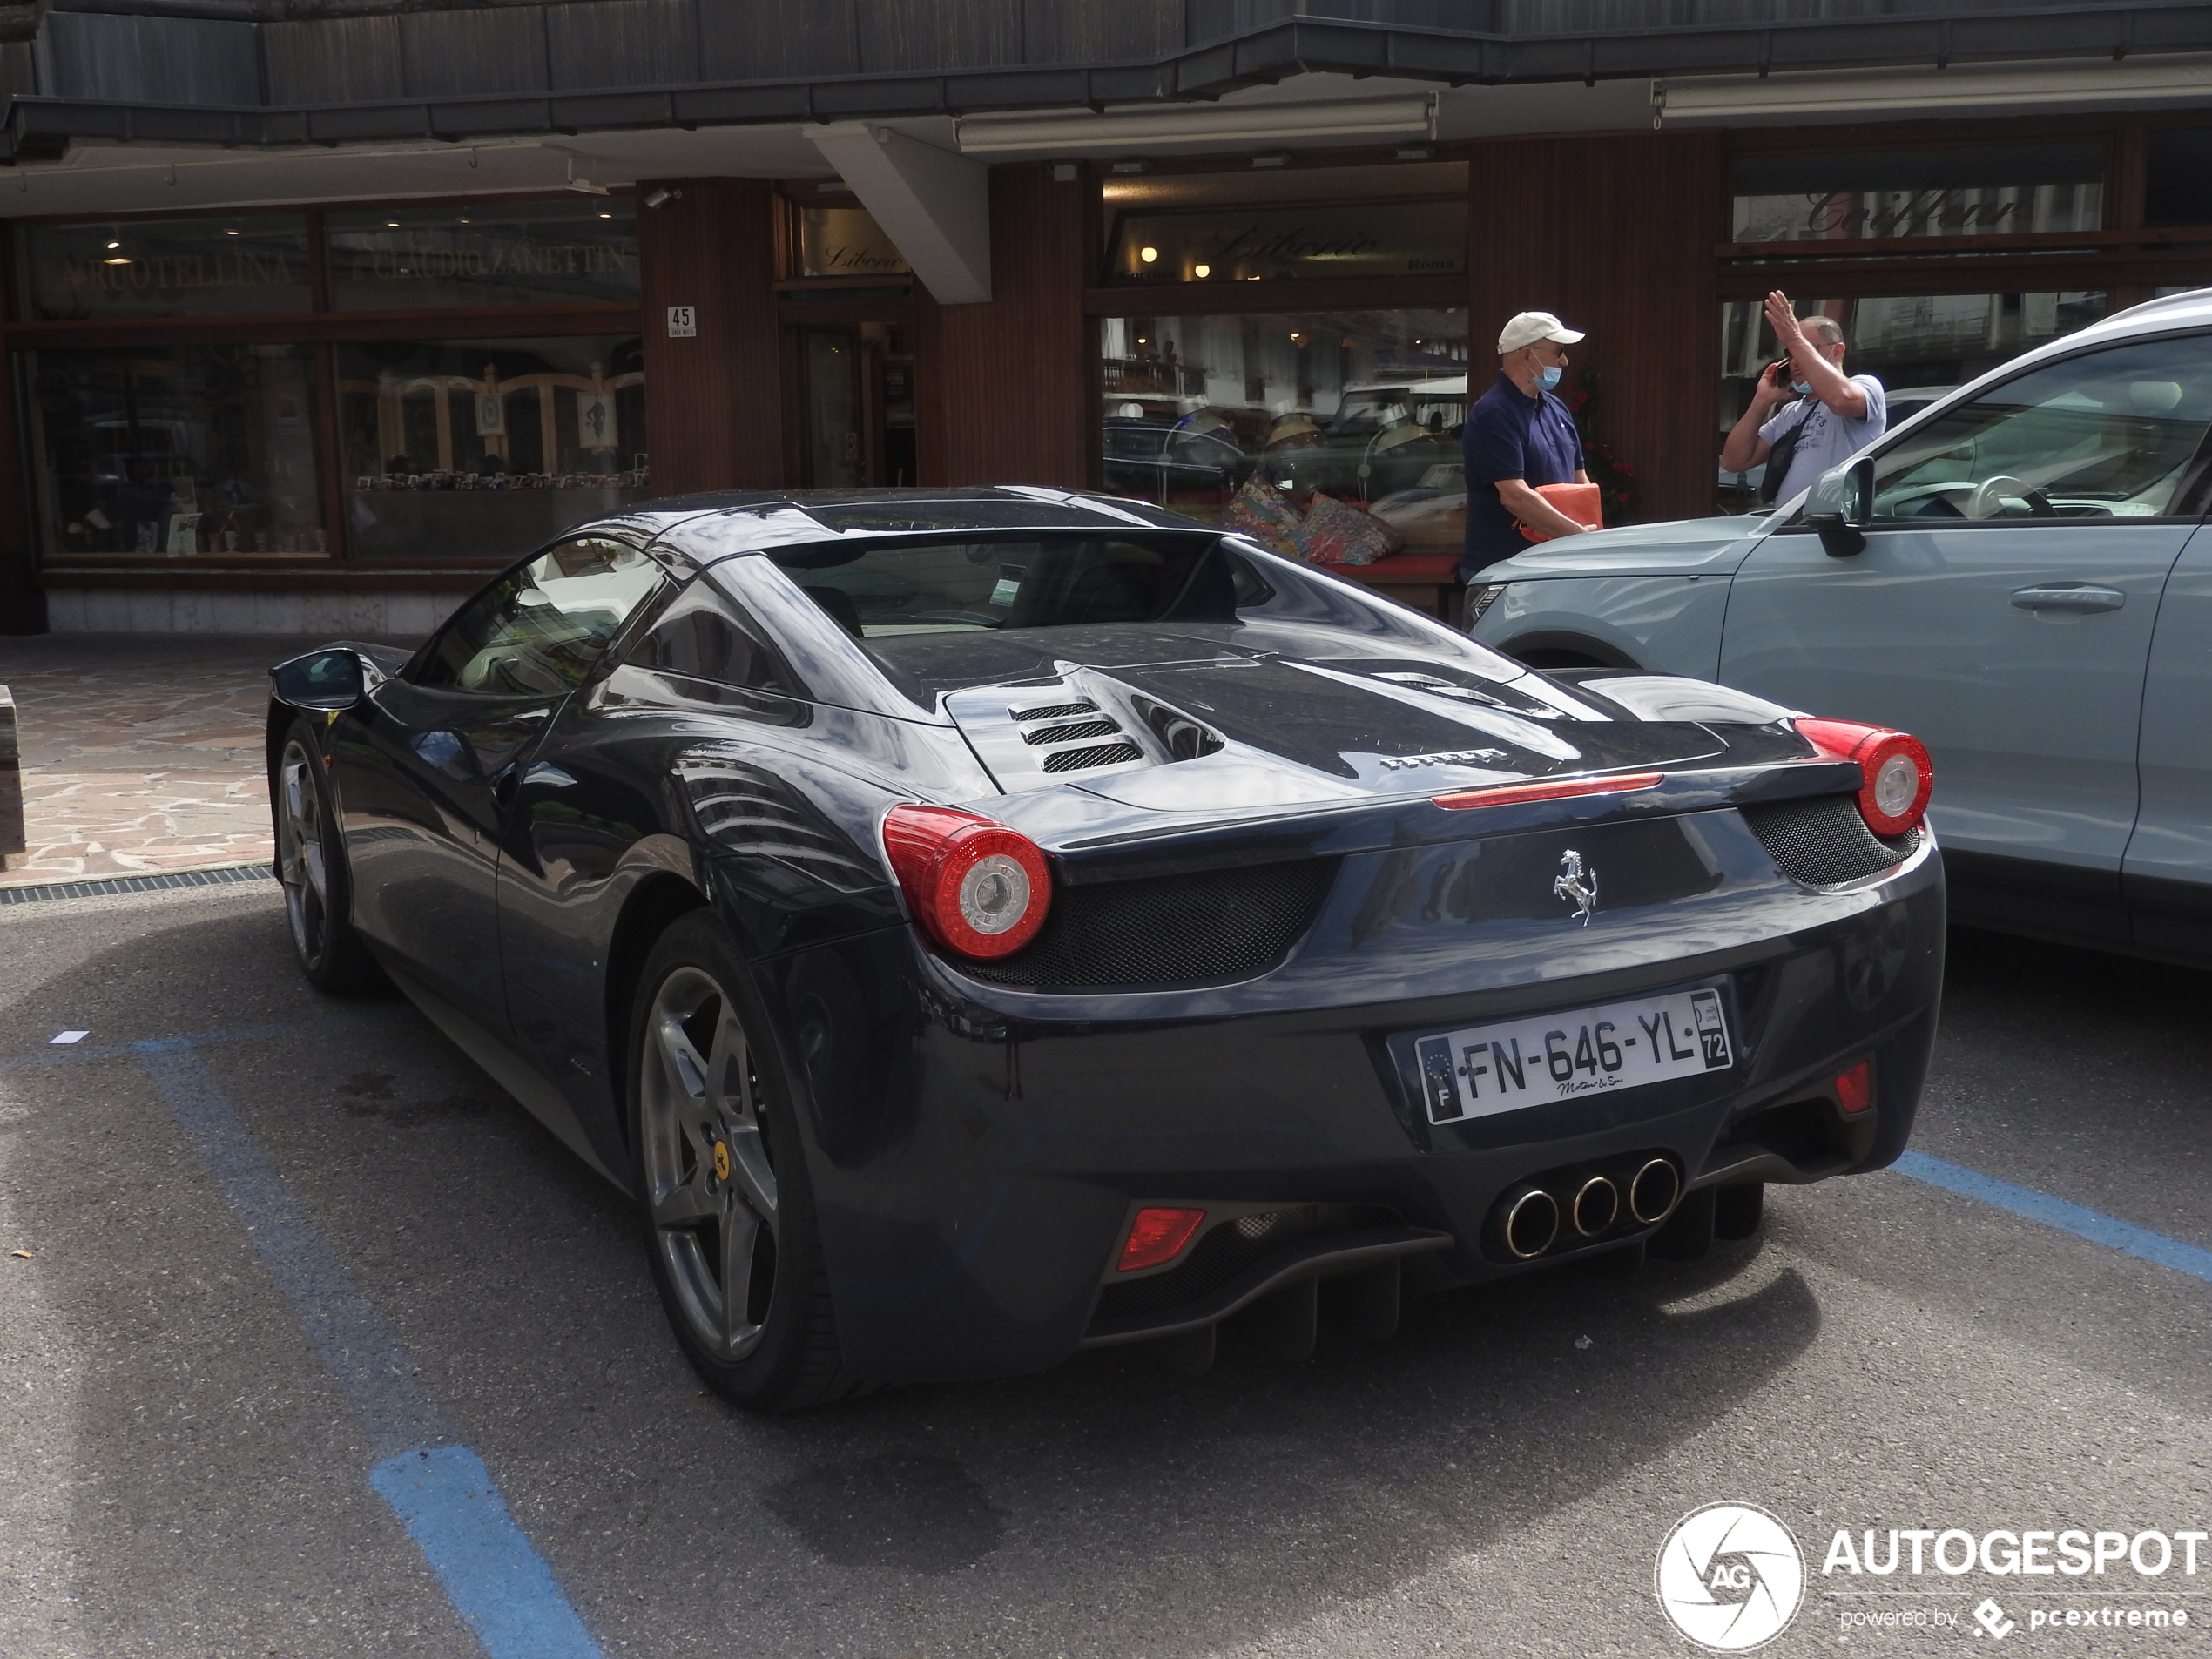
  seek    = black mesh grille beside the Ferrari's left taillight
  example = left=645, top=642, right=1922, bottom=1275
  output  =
left=960, top=859, right=1336, bottom=988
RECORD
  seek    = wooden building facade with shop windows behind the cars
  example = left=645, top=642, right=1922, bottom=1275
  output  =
left=0, top=7, right=2212, bottom=632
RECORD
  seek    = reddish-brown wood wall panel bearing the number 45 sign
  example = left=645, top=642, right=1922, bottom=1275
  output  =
left=637, top=179, right=787, bottom=496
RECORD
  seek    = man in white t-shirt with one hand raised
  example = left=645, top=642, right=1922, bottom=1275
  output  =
left=1721, top=290, right=1889, bottom=502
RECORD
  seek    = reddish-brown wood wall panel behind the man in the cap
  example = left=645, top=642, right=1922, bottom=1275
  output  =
left=1467, top=132, right=1723, bottom=520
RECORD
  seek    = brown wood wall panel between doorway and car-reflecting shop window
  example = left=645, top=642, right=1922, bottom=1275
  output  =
left=914, top=166, right=1099, bottom=489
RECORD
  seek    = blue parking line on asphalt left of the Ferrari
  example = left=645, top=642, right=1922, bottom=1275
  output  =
left=126, top=1027, right=599, bottom=1659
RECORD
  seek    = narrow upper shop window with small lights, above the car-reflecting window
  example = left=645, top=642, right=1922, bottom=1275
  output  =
left=1103, top=161, right=1467, bottom=283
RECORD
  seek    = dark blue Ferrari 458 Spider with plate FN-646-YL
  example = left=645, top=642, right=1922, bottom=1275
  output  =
left=267, top=489, right=1945, bottom=1409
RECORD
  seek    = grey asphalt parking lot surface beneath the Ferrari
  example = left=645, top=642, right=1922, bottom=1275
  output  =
left=0, top=882, right=2212, bottom=1659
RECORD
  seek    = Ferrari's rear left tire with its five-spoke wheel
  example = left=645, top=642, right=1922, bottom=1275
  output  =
left=628, top=911, right=863, bottom=1412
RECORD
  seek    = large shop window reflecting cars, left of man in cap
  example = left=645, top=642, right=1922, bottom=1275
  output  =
left=1099, top=307, right=1488, bottom=546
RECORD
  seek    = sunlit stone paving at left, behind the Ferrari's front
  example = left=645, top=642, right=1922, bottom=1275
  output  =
left=0, top=635, right=411, bottom=887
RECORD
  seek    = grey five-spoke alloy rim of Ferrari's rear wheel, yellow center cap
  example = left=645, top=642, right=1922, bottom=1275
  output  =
left=637, top=967, right=779, bottom=1363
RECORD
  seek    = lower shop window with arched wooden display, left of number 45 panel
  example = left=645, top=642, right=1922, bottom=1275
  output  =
left=336, top=336, right=648, bottom=560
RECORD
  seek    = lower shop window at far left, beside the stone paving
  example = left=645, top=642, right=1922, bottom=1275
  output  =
left=20, top=345, right=327, bottom=557
